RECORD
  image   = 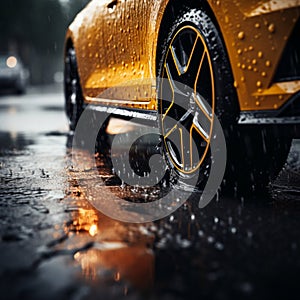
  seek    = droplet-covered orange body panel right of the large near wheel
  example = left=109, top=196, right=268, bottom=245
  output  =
left=210, top=0, right=300, bottom=110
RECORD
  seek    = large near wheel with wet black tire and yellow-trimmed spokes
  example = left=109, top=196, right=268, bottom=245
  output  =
left=157, top=8, right=238, bottom=190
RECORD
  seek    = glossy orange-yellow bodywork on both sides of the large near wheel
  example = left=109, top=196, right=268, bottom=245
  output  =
left=66, top=0, right=300, bottom=111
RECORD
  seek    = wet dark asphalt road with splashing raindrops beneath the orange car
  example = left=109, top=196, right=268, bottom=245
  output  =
left=0, top=87, right=300, bottom=299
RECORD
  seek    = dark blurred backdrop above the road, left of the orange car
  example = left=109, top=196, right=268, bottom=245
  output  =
left=0, top=0, right=89, bottom=85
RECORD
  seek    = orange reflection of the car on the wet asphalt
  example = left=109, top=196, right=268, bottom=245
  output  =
left=64, top=164, right=154, bottom=294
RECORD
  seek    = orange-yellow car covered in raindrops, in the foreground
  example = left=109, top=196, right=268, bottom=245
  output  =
left=65, top=0, right=300, bottom=190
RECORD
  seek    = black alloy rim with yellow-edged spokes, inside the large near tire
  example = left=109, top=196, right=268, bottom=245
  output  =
left=159, top=25, right=215, bottom=175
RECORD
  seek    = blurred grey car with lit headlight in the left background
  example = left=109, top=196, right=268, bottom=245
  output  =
left=0, top=54, right=29, bottom=94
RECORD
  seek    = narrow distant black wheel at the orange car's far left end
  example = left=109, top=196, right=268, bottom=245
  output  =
left=64, top=47, right=83, bottom=131
